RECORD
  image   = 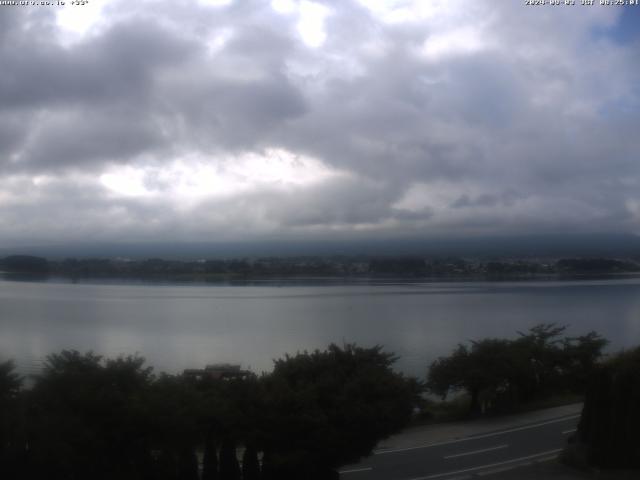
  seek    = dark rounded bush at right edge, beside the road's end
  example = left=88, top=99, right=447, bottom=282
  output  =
left=577, top=347, right=640, bottom=468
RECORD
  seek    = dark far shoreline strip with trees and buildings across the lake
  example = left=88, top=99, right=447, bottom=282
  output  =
left=0, top=255, right=640, bottom=285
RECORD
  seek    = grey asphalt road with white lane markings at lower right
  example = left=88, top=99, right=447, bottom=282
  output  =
left=340, top=415, right=580, bottom=480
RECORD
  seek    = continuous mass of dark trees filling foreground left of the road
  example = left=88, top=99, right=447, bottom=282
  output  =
left=0, top=345, right=420, bottom=480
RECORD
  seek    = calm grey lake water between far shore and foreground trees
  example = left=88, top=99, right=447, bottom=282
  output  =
left=0, top=278, right=640, bottom=376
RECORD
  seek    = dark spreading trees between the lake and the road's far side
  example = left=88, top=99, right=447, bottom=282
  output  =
left=427, top=324, right=608, bottom=414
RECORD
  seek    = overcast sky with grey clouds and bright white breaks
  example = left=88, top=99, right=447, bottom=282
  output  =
left=0, top=0, right=640, bottom=247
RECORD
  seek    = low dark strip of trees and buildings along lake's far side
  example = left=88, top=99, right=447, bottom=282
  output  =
left=0, top=255, right=640, bottom=281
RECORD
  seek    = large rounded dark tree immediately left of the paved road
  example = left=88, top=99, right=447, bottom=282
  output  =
left=263, top=344, right=421, bottom=480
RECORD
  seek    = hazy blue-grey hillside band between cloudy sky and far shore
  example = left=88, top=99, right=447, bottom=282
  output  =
left=0, top=234, right=640, bottom=260
